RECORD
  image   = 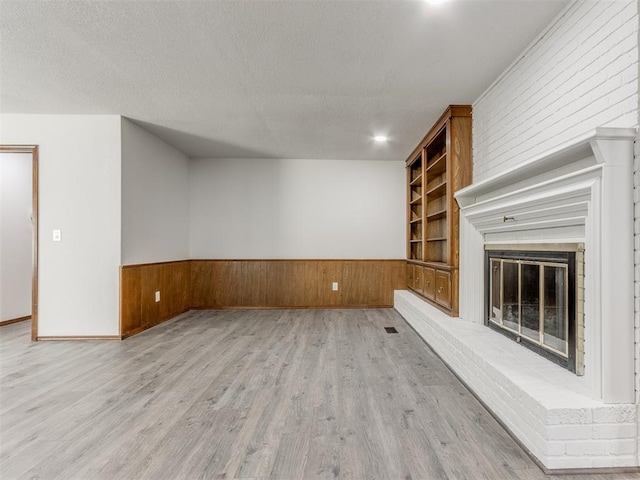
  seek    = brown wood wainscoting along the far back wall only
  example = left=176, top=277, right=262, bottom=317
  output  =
left=191, top=260, right=405, bottom=308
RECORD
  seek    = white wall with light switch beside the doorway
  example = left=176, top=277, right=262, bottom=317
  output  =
left=0, top=114, right=121, bottom=336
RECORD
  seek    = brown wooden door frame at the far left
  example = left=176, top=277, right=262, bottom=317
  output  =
left=0, top=145, right=38, bottom=341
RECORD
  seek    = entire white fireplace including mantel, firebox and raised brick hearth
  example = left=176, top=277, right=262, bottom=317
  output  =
left=395, top=128, right=639, bottom=471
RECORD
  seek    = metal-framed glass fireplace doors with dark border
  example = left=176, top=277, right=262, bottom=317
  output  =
left=485, top=248, right=582, bottom=375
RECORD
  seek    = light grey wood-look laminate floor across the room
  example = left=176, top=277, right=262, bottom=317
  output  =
left=0, top=309, right=640, bottom=480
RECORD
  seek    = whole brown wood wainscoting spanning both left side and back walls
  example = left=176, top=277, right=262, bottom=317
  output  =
left=120, top=260, right=405, bottom=338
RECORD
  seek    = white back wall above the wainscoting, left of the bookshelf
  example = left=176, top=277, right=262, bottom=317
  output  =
left=190, top=159, right=406, bottom=259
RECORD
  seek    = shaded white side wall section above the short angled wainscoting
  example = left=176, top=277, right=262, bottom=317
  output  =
left=122, top=118, right=189, bottom=265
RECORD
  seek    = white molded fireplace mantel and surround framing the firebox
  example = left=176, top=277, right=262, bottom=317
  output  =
left=455, top=128, right=636, bottom=403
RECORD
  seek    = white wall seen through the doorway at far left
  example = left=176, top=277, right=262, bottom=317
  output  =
left=0, top=152, right=32, bottom=321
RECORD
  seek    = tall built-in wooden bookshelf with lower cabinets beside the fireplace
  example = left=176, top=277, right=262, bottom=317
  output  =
left=407, top=105, right=472, bottom=316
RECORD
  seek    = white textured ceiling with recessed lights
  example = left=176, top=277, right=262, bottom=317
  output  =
left=0, top=0, right=568, bottom=160
